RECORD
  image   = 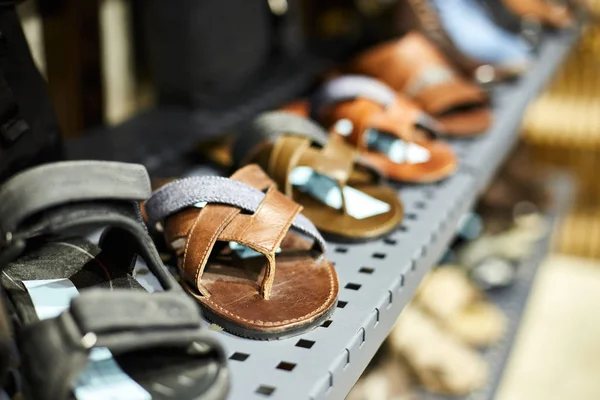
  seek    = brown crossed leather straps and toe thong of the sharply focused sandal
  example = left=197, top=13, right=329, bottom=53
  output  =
left=165, top=165, right=302, bottom=299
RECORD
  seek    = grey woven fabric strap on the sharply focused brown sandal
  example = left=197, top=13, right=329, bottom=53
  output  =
left=146, top=176, right=327, bottom=253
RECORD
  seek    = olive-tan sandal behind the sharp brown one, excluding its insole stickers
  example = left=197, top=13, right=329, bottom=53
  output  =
left=236, top=111, right=403, bottom=241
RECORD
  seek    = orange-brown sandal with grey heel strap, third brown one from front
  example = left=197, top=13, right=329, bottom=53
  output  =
left=313, top=76, right=458, bottom=183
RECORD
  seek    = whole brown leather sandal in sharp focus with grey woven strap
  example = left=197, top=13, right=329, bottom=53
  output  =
left=145, top=165, right=338, bottom=340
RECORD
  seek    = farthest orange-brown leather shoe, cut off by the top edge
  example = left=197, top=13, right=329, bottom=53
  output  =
left=502, top=0, right=575, bottom=28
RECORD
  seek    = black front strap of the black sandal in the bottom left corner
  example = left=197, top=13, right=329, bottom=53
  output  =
left=18, top=289, right=225, bottom=400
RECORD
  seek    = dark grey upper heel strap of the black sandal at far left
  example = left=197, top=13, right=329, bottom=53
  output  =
left=0, top=161, right=151, bottom=232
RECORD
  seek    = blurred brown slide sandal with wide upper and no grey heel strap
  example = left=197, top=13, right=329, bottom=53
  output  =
left=347, top=32, right=492, bottom=137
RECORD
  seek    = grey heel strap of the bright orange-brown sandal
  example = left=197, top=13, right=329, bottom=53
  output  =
left=312, top=75, right=396, bottom=117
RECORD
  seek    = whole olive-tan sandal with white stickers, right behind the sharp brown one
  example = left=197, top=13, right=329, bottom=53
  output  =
left=233, top=111, right=403, bottom=242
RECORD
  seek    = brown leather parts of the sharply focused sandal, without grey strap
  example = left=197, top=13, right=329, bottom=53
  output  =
left=159, top=165, right=338, bottom=336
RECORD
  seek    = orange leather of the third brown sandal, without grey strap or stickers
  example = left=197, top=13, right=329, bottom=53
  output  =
left=322, top=97, right=458, bottom=183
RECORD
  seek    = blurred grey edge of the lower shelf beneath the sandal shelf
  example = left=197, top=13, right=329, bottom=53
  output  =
left=421, top=176, right=573, bottom=400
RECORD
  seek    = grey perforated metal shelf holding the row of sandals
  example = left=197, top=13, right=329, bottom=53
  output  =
left=127, top=31, right=577, bottom=400
